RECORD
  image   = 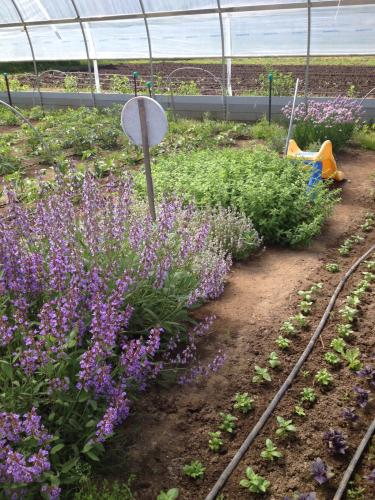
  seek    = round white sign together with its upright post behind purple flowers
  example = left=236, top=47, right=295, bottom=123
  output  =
left=121, top=96, right=168, bottom=220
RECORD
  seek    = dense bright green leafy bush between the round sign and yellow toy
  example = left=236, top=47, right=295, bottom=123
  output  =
left=135, top=147, right=338, bottom=246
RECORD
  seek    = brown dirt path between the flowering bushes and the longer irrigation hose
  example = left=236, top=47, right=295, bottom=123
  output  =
left=100, top=150, right=375, bottom=500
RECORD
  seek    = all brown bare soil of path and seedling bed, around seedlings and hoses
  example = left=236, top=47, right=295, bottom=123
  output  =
left=100, top=150, right=375, bottom=500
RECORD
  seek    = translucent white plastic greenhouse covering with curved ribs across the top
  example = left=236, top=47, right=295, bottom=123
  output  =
left=0, top=0, right=375, bottom=62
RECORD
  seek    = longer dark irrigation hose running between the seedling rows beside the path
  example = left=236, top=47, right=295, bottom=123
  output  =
left=205, top=245, right=375, bottom=500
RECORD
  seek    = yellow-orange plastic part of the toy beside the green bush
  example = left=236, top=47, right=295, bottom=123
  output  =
left=287, top=139, right=344, bottom=181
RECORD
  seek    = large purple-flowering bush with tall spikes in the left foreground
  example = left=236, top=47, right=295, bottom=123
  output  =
left=0, top=175, right=231, bottom=499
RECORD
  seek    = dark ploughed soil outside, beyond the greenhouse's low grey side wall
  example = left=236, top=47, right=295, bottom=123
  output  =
left=19, top=62, right=375, bottom=97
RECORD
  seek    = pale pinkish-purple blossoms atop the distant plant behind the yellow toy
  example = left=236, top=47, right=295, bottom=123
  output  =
left=282, top=97, right=363, bottom=127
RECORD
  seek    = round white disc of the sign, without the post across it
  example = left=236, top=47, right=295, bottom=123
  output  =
left=121, top=96, right=168, bottom=146
